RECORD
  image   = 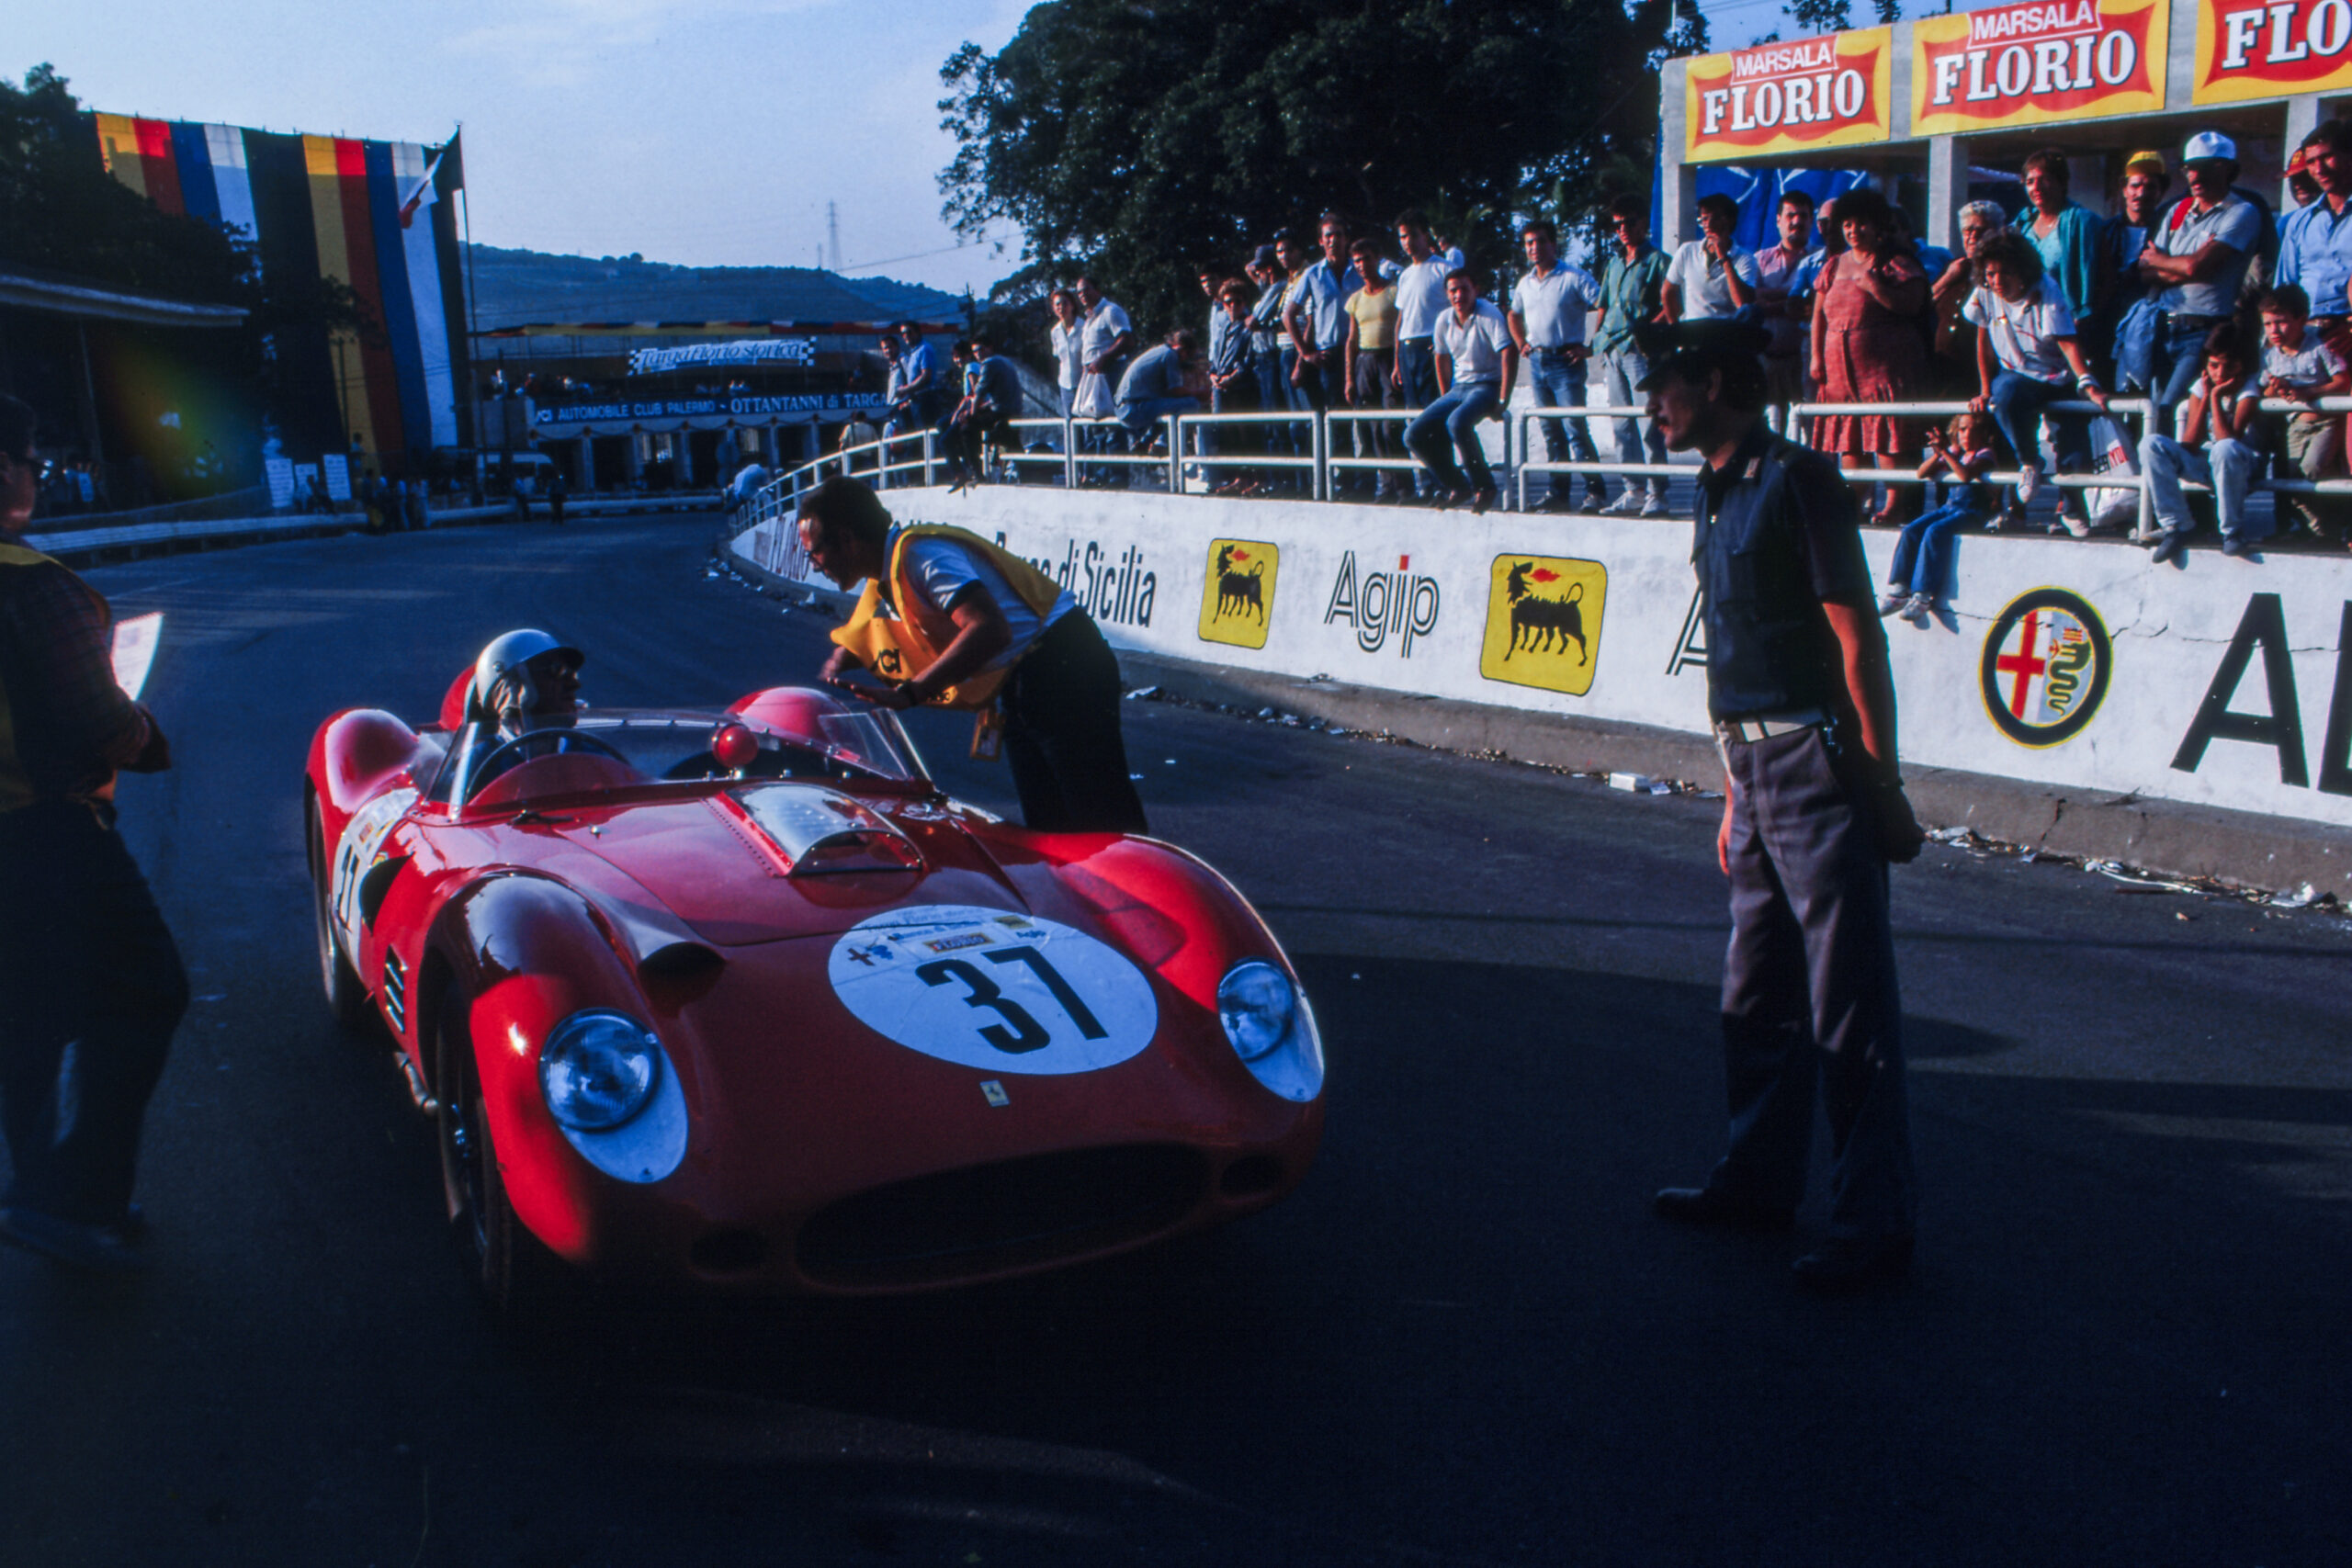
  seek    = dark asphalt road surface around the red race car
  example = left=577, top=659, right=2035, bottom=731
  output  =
left=0, top=520, right=2352, bottom=1568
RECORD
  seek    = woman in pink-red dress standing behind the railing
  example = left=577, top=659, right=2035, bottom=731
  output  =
left=1814, top=186, right=1928, bottom=525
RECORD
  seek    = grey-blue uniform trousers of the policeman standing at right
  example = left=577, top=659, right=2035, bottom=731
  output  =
left=1710, top=727, right=1917, bottom=1236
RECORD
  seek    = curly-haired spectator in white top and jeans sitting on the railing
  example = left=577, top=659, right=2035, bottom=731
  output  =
left=1959, top=228, right=2108, bottom=538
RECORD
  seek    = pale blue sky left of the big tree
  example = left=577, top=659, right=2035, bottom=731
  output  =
left=0, top=0, right=1028, bottom=291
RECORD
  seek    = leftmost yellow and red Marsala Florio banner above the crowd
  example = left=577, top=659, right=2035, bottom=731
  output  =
left=1684, top=28, right=1894, bottom=163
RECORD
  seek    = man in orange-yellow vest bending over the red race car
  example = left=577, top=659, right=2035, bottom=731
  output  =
left=799, top=475, right=1148, bottom=832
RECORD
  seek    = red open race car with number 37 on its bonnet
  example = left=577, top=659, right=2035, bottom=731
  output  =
left=306, top=658, right=1324, bottom=1307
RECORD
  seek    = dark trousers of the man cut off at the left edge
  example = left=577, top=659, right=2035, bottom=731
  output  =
left=0, top=802, right=188, bottom=1224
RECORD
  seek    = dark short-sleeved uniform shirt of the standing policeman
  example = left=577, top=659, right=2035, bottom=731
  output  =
left=1691, top=421, right=1870, bottom=719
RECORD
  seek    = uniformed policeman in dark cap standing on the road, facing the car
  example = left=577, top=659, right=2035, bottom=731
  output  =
left=1642, top=322, right=1922, bottom=1291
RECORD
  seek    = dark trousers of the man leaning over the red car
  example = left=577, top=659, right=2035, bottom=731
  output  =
left=1000, top=611, right=1150, bottom=832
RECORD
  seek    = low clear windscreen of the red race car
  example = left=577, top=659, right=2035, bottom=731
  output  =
left=428, top=710, right=924, bottom=802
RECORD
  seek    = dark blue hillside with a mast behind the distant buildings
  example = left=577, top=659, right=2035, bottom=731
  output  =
left=468, top=244, right=965, bottom=332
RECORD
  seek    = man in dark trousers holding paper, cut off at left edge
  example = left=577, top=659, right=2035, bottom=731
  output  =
left=0, top=398, right=188, bottom=1272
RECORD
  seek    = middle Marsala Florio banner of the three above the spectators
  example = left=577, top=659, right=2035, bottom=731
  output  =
left=1910, top=0, right=2168, bottom=136
